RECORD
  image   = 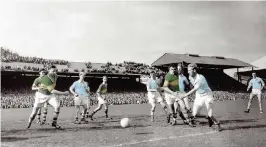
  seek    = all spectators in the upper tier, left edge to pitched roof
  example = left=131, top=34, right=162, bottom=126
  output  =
left=1, top=47, right=164, bottom=75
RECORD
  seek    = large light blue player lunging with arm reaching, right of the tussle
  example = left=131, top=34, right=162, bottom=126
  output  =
left=181, top=64, right=221, bottom=131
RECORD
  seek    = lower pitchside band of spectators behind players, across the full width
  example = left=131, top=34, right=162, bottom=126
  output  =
left=1, top=88, right=266, bottom=109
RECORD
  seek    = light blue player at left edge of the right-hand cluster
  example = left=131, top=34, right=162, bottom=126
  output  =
left=146, top=71, right=169, bottom=122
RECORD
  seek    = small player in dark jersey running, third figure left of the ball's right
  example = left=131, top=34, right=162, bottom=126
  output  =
left=89, top=76, right=108, bottom=120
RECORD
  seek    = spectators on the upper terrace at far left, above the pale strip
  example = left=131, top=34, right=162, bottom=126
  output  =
left=1, top=47, right=68, bottom=65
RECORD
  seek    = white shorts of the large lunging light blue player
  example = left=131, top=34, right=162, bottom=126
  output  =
left=194, top=92, right=214, bottom=107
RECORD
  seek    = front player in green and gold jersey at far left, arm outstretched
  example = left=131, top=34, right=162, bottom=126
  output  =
left=27, top=66, right=69, bottom=129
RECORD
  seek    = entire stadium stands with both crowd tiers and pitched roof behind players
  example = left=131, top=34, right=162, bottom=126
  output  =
left=1, top=48, right=262, bottom=109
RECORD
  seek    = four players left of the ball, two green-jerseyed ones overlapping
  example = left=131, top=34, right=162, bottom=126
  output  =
left=27, top=66, right=108, bottom=129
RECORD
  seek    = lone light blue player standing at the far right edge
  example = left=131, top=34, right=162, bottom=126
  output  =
left=245, top=73, right=265, bottom=113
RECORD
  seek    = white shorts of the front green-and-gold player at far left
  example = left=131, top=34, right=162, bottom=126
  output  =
left=34, top=92, right=60, bottom=108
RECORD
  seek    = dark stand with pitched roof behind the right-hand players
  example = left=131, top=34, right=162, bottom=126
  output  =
left=152, top=53, right=254, bottom=91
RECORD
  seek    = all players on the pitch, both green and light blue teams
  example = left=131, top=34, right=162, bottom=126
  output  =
left=28, top=64, right=264, bottom=131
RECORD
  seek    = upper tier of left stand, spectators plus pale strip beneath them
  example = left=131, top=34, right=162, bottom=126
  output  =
left=1, top=47, right=162, bottom=74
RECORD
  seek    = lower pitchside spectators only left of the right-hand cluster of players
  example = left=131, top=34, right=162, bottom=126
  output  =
left=1, top=89, right=148, bottom=109
